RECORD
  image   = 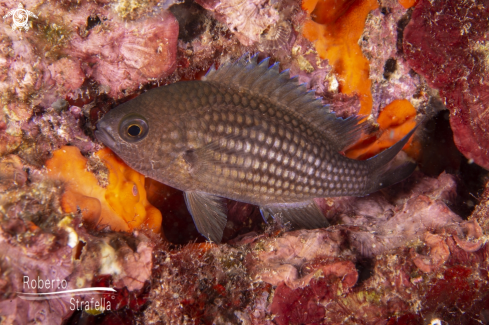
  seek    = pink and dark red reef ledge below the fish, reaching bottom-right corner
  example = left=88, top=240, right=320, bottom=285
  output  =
left=135, top=173, right=489, bottom=324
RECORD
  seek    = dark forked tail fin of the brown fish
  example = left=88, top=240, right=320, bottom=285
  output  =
left=366, top=126, right=417, bottom=193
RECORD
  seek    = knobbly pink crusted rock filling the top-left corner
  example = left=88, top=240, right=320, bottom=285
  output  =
left=0, top=1, right=178, bottom=106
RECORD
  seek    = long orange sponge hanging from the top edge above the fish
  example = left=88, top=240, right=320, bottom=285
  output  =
left=302, top=0, right=378, bottom=115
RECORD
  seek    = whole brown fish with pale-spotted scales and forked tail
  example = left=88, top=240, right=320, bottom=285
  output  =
left=95, top=55, right=416, bottom=242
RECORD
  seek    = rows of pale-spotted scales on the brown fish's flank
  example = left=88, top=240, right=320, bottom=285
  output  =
left=176, top=89, right=367, bottom=205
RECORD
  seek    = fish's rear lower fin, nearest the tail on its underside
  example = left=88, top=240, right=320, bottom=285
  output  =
left=260, top=200, right=329, bottom=229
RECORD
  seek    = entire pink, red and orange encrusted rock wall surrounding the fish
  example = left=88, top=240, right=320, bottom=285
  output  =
left=0, top=0, right=489, bottom=324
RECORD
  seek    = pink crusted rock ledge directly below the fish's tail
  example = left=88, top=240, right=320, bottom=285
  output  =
left=318, top=173, right=462, bottom=257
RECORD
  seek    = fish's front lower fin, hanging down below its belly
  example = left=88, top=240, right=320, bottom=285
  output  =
left=184, top=191, right=227, bottom=243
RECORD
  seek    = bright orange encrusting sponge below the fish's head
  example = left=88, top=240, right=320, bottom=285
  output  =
left=46, top=146, right=162, bottom=233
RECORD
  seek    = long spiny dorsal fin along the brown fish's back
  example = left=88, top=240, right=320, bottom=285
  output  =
left=202, top=54, right=366, bottom=151
